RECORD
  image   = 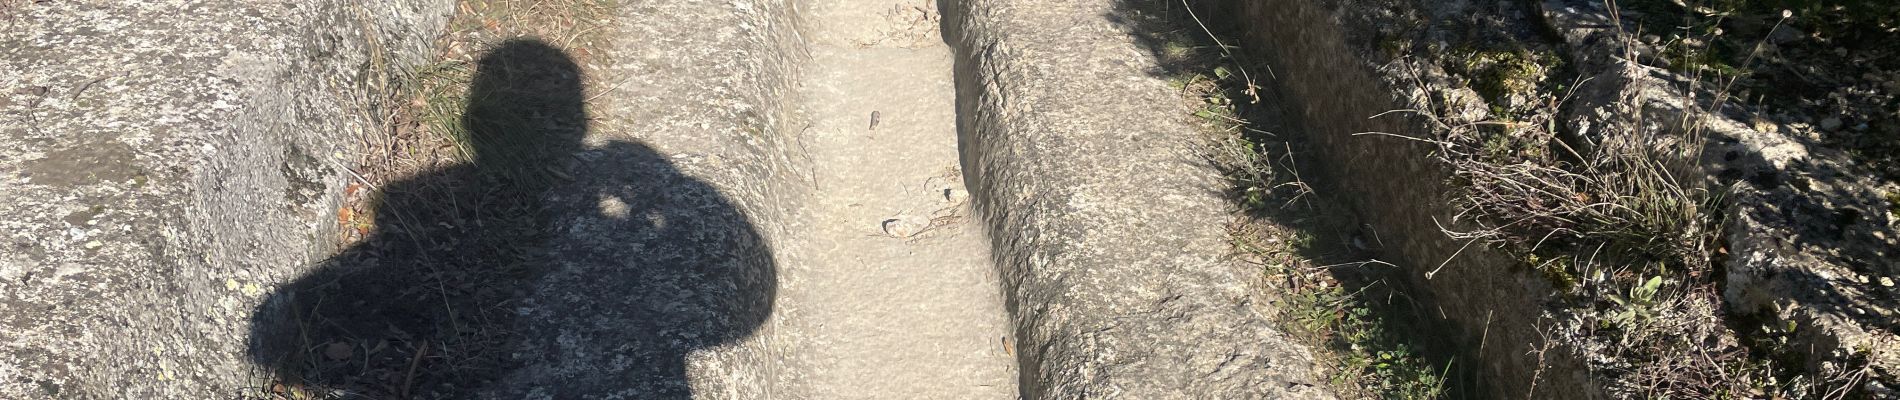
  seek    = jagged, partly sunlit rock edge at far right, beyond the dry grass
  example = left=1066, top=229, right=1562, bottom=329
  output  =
left=1543, top=0, right=1900, bottom=388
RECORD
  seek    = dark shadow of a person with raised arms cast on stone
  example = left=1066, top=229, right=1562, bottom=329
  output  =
left=249, top=40, right=777, bottom=398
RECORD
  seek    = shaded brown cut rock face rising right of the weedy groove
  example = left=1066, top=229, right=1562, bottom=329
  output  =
left=1220, top=0, right=1606, bottom=398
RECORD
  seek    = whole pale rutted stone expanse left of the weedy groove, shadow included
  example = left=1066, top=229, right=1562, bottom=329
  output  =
left=0, top=0, right=1330, bottom=398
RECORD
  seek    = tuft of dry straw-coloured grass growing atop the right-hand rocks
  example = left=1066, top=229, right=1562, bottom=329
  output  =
left=1431, top=106, right=1720, bottom=278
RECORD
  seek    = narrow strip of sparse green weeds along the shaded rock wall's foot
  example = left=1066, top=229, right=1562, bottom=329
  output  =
left=1117, top=6, right=1452, bottom=398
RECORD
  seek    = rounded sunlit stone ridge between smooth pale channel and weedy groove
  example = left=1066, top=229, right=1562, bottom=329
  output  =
left=944, top=0, right=1330, bottom=398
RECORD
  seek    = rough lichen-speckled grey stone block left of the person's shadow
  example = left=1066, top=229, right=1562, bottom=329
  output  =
left=0, top=0, right=448, bottom=398
